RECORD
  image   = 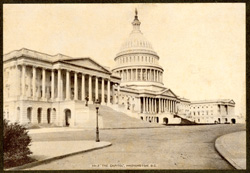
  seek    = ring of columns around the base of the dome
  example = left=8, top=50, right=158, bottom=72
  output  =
left=116, top=68, right=163, bottom=82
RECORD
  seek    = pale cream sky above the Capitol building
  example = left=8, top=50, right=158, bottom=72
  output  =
left=3, top=3, right=246, bottom=116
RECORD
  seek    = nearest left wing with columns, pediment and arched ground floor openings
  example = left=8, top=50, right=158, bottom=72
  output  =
left=4, top=49, right=120, bottom=126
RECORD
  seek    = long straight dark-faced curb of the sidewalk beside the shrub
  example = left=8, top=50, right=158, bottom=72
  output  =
left=5, top=143, right=112, bottom=171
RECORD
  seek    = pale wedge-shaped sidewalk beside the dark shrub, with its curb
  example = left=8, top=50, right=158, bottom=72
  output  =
left=9, top=141, right=112, bottom=170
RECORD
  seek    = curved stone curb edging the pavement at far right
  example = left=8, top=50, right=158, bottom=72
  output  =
left=215, top=131, right=245, bottom=170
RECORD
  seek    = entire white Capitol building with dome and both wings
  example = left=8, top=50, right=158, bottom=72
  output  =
left=3, top=11, right=242, bottom=126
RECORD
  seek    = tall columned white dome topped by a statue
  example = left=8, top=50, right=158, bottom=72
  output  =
left=112, top=10, right=163, bottom=89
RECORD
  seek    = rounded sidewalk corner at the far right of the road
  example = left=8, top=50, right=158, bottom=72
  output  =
left=215, top=131, right=246, bottom=169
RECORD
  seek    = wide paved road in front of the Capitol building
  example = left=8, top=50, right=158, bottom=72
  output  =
left=26, top=124, right=246, bottom=170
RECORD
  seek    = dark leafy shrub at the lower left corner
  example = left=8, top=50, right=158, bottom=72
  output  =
left=3, top=120, right=32, bottom=168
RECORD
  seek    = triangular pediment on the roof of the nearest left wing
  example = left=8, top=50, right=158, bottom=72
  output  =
left=63, top=58, right=110, bottom=73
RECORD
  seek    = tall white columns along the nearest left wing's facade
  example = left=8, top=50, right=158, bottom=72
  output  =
left=21, top=64, right=110, bottom=104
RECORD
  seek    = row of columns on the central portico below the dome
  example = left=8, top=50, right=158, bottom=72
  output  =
left=141, top=97, right=177, bottom=113
